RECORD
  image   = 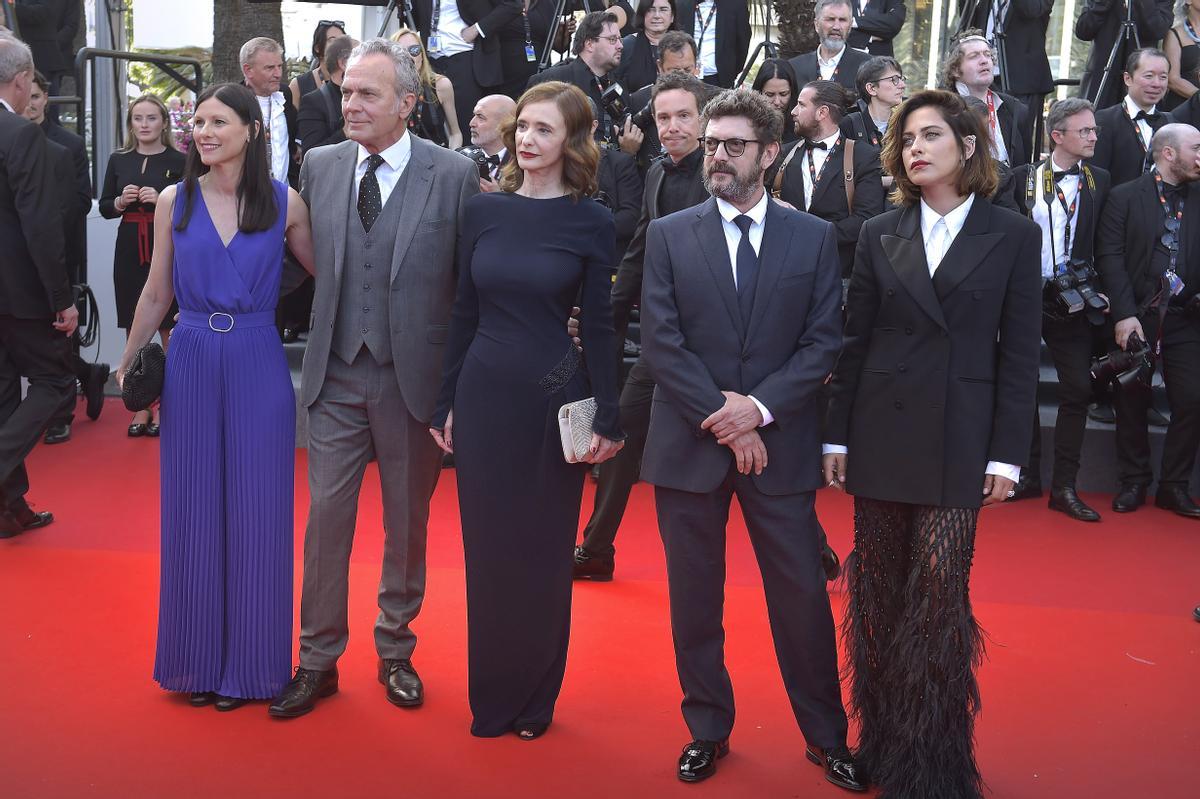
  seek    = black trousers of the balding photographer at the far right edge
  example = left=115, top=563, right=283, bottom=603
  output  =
left=1112, top=308, right=1200, bottom=488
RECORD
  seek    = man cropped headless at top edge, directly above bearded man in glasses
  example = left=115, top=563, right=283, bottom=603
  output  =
left=676, top=0, right=750, bottom=89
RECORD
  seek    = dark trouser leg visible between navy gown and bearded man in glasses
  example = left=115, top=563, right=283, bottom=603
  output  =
left=583, top=358, right=654, bottom=557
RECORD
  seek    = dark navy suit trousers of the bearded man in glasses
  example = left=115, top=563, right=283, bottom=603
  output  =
left=654, top=468, right=846, bottom=747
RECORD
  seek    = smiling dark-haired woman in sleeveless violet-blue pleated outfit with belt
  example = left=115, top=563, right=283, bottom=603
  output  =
left=118, top=83, right=312, bottom=710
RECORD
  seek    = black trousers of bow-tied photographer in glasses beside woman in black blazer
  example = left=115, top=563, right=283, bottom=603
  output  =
left=1026, top=313, right=1092, bottom=488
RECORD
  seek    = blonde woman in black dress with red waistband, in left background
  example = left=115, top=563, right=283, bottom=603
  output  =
left=100, top=95, right=185, bottom=438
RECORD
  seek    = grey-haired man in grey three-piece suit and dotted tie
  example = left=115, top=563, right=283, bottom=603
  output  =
left=270, top=38, right=479, bottom=719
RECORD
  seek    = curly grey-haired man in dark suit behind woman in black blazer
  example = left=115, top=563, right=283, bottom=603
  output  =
left=938, top=28, right=1032, bottom=168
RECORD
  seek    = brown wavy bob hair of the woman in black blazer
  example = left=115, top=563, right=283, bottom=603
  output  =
left=881, top=89, right=1000, bottom=205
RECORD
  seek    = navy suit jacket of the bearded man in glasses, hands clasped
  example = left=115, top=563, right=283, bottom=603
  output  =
left=642, top=199, right=844, bottom=495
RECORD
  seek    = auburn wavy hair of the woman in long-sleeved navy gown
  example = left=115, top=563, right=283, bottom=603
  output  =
left=500, top=80, right=600, bottom=202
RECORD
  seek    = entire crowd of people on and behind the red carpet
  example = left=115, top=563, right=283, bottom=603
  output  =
left=0, top=0, right=1200, bottom=799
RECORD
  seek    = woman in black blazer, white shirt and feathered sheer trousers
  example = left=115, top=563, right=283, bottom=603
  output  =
left=824, top=91, right=1042, bottom=799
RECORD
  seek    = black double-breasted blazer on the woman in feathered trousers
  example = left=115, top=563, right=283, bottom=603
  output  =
left=825, top=196, right=1042, bottom=507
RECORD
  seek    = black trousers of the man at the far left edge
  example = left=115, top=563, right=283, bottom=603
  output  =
left=0, top=316, right=74, bottom=507
